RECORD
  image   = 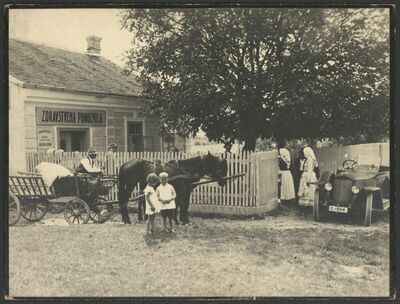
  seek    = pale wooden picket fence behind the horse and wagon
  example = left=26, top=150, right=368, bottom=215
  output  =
left=27, top=151, right=278, bottom=213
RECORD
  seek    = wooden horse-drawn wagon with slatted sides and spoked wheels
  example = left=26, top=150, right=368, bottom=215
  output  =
left=9, top=174, right=117, bottom=226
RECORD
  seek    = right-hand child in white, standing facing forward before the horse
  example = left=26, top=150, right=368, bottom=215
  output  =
left=156, top=172, right=176, bottom=233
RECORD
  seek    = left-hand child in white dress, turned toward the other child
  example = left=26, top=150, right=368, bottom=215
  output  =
left=144, top=173, right=159, bottom=235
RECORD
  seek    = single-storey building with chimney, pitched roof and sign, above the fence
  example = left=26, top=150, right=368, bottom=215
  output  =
left=9, top=37, right=185, bottom=172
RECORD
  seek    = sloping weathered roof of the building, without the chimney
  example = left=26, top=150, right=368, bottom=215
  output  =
left=9, top=39, right=141, bottom=96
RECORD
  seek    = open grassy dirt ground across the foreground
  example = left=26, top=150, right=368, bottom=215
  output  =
left=9, top=206, right=389, bottom=297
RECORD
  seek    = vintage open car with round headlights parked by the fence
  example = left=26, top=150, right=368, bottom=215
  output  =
left=313, top=159, right=390, bottom=226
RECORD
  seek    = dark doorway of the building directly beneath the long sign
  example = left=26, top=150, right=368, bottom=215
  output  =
left=58, top=129, right=89, bottom=152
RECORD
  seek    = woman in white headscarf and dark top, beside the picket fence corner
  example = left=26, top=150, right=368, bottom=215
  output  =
left=278, top=148, right=296, bottom=201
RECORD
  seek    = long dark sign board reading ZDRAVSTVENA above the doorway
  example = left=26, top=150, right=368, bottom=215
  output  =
left=36, top=107, right=106, bottom=126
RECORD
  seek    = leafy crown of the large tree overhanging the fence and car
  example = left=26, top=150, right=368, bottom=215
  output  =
left=122, top=8, right=389, bottom=150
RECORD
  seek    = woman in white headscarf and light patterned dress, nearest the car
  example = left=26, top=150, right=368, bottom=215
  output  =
left=297, top=147, right=318, bottom=207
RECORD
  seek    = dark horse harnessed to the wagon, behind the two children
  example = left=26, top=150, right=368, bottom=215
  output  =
left=118, top=153, right=228, bottom=224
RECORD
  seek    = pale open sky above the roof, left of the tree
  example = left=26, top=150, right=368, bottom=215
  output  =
left=9, top=9, right=133, bottom=66
